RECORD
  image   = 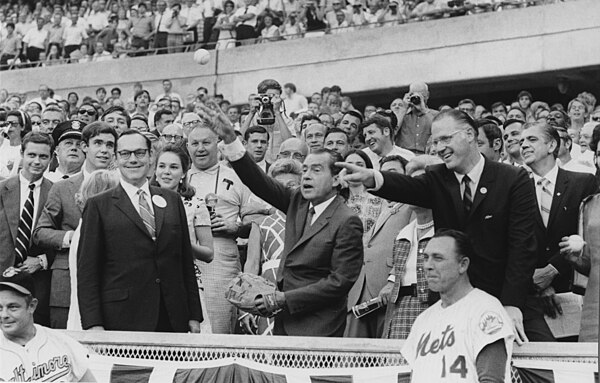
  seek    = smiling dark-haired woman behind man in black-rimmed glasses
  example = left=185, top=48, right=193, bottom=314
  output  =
left=155, top=144, right=213, bottom=334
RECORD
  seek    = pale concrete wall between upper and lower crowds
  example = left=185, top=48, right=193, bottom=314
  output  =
left=0, top=0, right=600, bottom=103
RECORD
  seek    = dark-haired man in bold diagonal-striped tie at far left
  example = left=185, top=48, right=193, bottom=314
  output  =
left=0, top=133, right=54, bottom=326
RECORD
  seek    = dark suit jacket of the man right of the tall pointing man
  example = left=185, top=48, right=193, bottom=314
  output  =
left=532, top=168, right=598, bottom=293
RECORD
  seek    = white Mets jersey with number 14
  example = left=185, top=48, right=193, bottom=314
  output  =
left=402, top=289, right=514, bottom=383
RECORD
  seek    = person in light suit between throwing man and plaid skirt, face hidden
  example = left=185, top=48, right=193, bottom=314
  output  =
left=344, top=155, right=412, bottom=338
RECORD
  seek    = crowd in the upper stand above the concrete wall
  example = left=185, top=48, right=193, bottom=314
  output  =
left=0, top=0, right=554, bottom=69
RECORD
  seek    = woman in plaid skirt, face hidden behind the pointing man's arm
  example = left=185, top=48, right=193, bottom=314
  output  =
left=379, top=155, right=441, bottom=339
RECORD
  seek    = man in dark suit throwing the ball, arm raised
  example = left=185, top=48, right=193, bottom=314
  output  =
left=206, top=106, right=363, bottom=337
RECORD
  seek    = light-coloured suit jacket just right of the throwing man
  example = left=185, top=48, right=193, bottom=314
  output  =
left=348, top=201, right=412, bottom=311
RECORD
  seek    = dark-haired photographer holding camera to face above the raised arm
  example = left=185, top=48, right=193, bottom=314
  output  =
left=241, top=79, right=293, bottom=163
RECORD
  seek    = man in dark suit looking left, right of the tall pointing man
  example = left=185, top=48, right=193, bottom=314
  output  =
left=521, top=122, right=597, bottom=342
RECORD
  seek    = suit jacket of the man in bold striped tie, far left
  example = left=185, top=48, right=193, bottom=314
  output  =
left=0, top=175, right=54, bottom=273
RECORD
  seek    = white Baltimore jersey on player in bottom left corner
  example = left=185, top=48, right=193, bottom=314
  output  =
left=0, top=324, right=88, bottom=382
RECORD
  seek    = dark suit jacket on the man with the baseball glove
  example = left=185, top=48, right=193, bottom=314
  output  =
left=231, top=153, right=363, bottom=336
